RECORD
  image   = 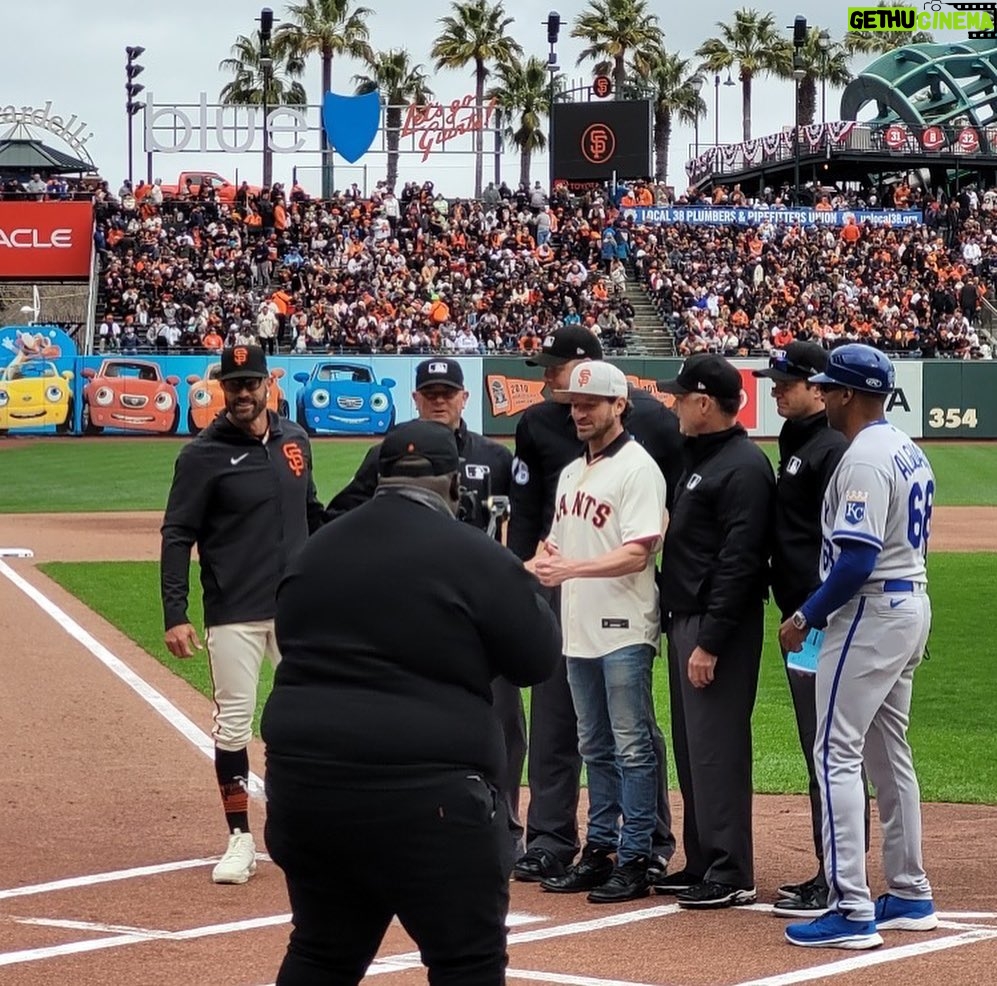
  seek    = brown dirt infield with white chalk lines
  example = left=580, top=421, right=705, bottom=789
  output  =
left=0, top=508, right=997, bottom=986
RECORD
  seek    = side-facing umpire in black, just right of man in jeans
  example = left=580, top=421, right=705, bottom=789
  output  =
left=655, top=353, right=775, bottom=908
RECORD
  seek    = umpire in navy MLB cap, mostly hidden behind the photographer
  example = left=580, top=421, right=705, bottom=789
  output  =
left=326, top=356, right=526, bottom=855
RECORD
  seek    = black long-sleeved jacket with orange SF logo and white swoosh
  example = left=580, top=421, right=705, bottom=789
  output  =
left=160, top=411, right=323, bottom=630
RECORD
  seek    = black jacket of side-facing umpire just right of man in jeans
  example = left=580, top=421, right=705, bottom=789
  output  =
left=660, top=425, right=775, bottom=654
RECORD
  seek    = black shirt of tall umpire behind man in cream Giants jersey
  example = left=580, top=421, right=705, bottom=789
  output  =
left=508, top=387, right=682, bottom=561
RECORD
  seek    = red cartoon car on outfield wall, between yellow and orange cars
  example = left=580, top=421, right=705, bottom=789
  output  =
left=83, top=359, right=180, bottom=435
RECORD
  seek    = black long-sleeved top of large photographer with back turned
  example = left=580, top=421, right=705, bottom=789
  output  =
left=262, top=487, right=561, bottom=788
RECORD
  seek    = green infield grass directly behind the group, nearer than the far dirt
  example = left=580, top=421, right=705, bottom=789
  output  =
left=41, top=553, right=997, bottom=804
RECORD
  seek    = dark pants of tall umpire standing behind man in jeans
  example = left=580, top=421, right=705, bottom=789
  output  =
left=526, top=652, right=675, bottom=863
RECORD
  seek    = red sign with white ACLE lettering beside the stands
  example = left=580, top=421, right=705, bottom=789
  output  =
left=0, top=202, right=93, bottom=281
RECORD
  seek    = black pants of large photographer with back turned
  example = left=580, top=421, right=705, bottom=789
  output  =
left=266, top=769, right=509, bottom=986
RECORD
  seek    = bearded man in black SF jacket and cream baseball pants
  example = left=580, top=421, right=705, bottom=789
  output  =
left=160, top=346, right=323, bottom=883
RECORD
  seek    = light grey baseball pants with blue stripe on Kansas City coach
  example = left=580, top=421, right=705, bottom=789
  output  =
left=814, top=593, right=931, bottom=921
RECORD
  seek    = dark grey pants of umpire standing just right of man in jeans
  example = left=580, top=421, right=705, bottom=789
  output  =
left=668, top=602, right=763, bottom=889
